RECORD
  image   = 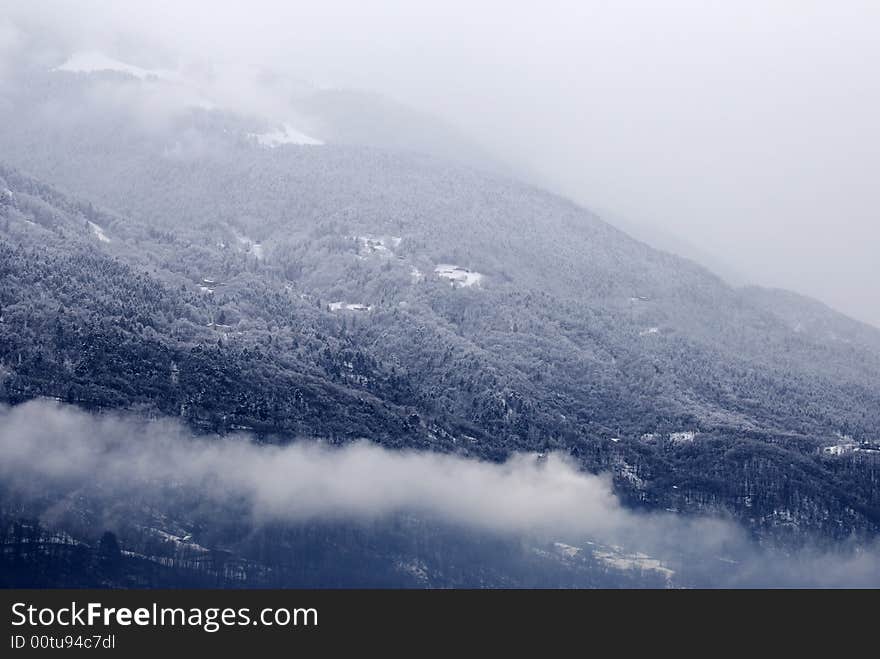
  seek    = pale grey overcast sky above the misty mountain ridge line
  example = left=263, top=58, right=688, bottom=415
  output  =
left=6, top=0, right=880, bottom=326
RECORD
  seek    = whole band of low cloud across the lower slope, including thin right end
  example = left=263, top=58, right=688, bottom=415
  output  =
left=0, top=401, right=880, bottom=586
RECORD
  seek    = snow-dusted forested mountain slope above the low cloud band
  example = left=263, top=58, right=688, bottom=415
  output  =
left=0, top=63, right=880, bottom=548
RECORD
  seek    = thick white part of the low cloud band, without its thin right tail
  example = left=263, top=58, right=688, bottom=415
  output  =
left=0, top=402, right=629, bottom=534
